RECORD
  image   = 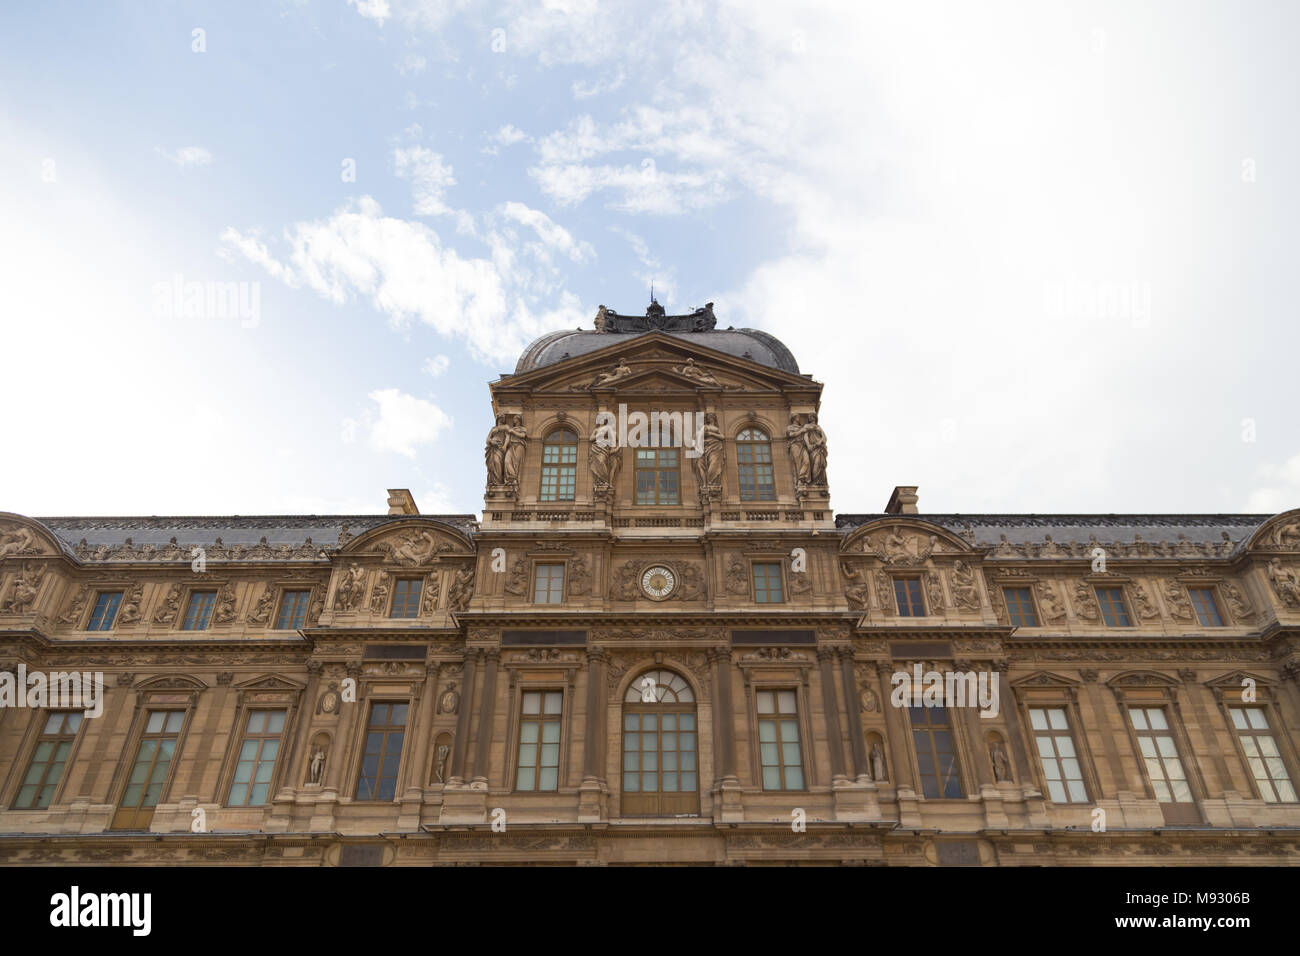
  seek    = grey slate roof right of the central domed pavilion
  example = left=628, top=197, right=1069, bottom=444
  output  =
left=835, top=514, right=1274, bottom=557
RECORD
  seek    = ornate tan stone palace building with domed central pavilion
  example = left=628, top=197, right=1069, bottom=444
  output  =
left=0, top=303, right=1300, bottom=866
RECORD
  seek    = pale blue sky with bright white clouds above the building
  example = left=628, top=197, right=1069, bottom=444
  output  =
left=0, top=0, right=1300, bottom=515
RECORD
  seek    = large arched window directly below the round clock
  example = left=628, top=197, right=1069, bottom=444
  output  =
left=623, top=670, right=699, bottom=817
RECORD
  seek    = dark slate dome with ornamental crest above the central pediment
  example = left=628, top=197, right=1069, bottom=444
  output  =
left=515, top=302, right=800, bottom=375
